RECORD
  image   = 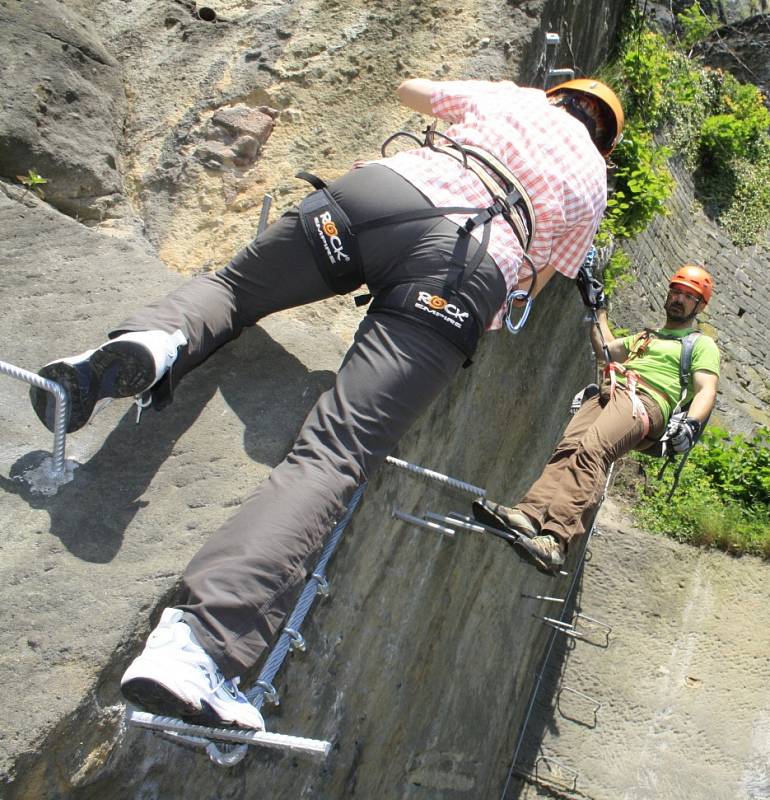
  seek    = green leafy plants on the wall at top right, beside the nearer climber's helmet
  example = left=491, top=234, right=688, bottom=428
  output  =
left=603, top=18, right=770, bottom=246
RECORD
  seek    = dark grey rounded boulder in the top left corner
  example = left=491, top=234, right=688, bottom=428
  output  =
left=0, top=0, right=126, bottom=220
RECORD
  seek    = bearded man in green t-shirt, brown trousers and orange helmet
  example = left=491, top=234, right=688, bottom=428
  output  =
left=473, top=264, right=720, bottom=575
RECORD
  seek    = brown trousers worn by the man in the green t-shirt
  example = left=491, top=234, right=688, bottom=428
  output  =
left=516, top=382, right=665, bottom=544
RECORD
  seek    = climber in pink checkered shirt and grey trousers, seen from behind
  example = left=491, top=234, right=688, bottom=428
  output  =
left=32, top=78, right=623, bottom=728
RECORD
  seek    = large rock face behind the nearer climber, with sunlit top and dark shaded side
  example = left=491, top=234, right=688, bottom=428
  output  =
left=0, top=0, right=764, bottom=800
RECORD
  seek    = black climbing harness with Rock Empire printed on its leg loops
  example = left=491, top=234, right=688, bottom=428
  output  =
left=297, top=127, right=536, bottom=366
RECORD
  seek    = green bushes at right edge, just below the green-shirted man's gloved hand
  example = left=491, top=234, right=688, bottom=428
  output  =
left=634, top=427, right=770, bottom=558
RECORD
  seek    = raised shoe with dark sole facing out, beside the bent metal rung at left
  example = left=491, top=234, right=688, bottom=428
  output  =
left=29, top=331, right=187, bottom=433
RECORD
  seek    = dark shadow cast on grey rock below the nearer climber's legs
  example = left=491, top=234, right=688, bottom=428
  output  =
left=0, top=328, right=334, bottom=563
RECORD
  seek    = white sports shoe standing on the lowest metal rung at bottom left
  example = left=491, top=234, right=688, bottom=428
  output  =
left=120, top=608, right=265, bottom=731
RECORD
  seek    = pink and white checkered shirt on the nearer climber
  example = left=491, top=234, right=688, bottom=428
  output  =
left=378, top=81, right=607, bottom=329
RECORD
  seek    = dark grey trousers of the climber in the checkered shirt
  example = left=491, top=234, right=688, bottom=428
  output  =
left=112, top=165, right=506, bottom=677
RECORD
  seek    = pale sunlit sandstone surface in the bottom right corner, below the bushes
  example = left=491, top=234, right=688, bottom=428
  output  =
left=506, top=502, right=770, bottom=800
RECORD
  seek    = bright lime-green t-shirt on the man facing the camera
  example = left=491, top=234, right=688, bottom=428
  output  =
left=622, top=328, right=720, bottom=419
